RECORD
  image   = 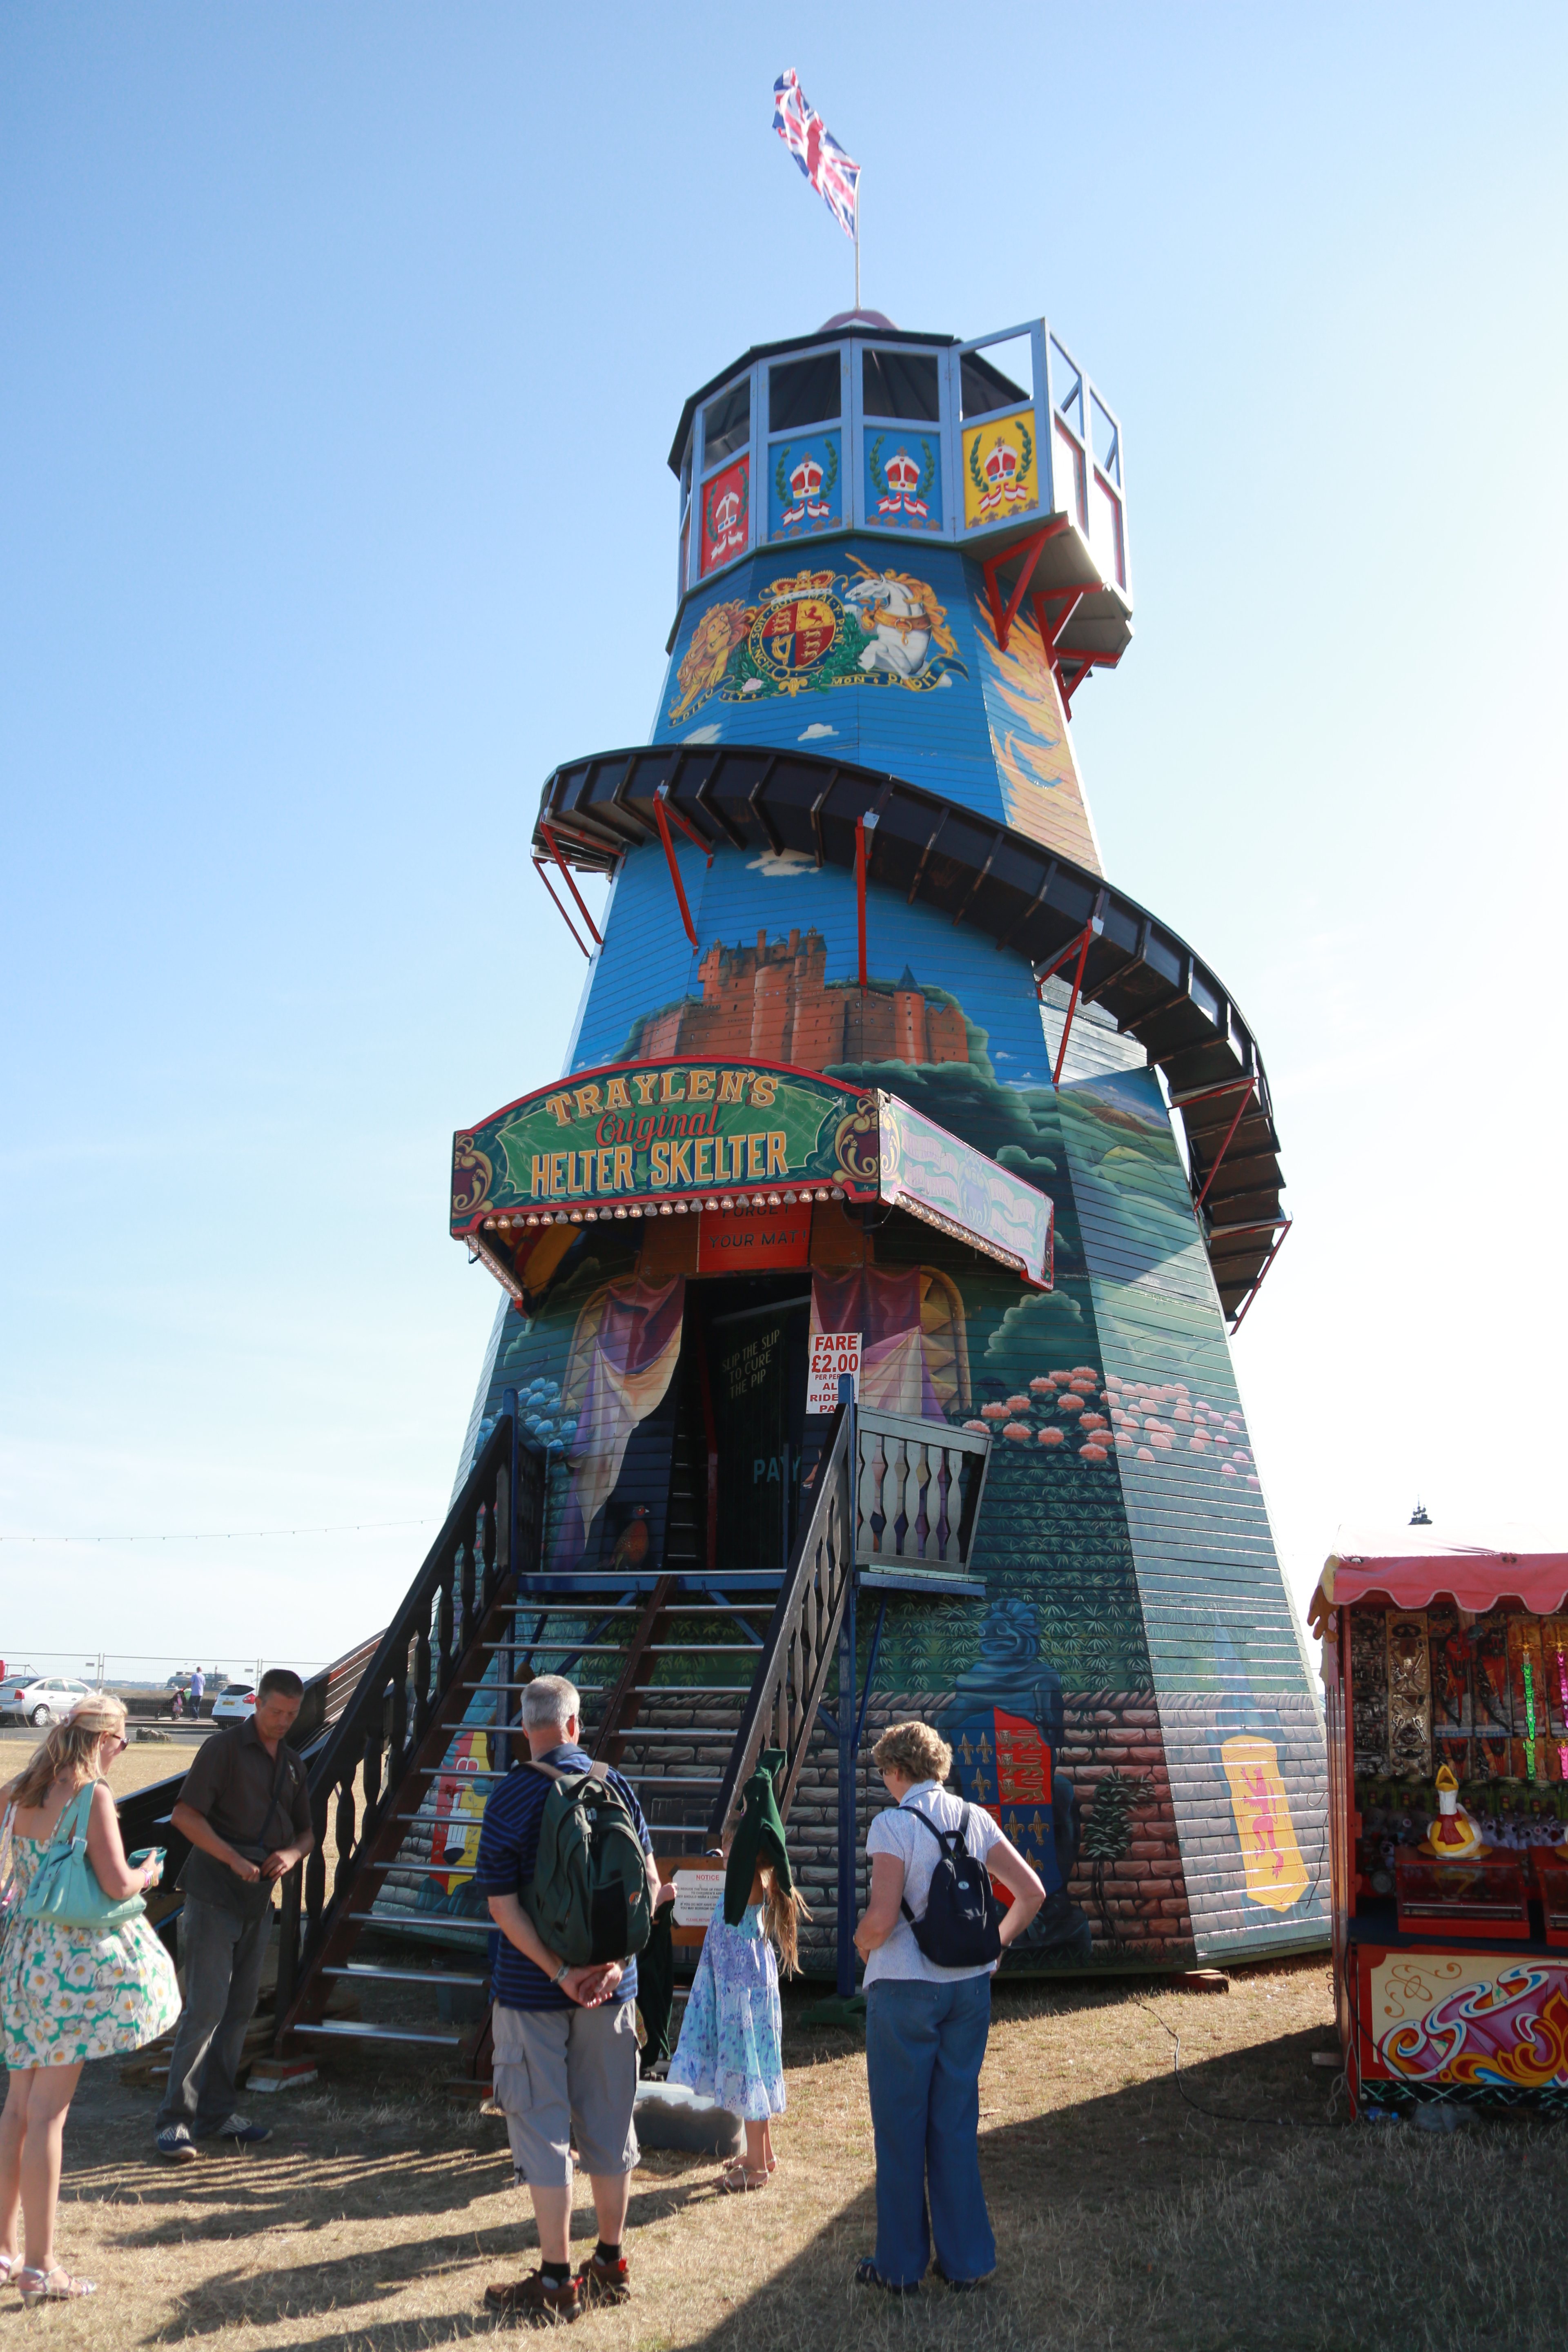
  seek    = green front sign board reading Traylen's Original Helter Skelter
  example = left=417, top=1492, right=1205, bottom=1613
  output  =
left=451, top=1061, right=879, bottom=1232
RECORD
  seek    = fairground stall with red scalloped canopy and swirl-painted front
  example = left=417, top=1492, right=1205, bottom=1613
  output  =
left=1312, top=1529, right=1568, bottom=2112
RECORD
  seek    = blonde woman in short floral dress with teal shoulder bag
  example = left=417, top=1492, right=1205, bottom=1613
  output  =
left=0, top=1693, right=179, bottom=2303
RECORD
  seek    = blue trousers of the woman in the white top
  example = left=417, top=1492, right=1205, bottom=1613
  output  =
left=865, top=1976, right=997, bottom=2286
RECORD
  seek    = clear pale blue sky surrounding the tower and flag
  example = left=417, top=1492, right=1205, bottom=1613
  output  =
left=0, top=0, right=1568, bottom=1663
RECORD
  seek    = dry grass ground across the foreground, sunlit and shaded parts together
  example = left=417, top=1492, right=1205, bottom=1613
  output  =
left=18, top=1964, right=1568, bottom=2352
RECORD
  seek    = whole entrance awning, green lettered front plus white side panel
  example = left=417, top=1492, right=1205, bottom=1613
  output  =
left=451, top=1061, right=1053, bottom=1289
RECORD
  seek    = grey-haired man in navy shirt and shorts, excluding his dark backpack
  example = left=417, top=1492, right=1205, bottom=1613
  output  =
left=472, top=1675, right=661, bottom=2319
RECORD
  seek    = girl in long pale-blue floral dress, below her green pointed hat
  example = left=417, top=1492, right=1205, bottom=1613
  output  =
left=670, top=1865, right=811, bottom=2190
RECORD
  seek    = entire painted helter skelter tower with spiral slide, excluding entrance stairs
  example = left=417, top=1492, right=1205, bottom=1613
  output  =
left=454, top=310, right=1326, bottom=1966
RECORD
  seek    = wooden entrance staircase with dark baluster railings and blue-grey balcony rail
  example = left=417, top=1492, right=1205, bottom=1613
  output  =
left=267, top=1392, right=987, bottom=2072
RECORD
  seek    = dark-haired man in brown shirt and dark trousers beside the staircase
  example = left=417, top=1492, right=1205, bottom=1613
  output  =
left=158, top=1665, right=315, bottom=2164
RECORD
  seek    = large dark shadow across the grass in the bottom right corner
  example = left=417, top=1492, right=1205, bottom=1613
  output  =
left=679, top=2032, right=1568, bottom=2352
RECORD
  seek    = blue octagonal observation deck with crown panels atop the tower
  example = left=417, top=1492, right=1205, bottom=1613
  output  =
left=670, top=310, right=1133, bottom=677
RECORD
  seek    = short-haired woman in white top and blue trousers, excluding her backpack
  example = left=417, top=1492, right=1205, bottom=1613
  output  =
left=856, top=1724, right=1046, bottom=2296
